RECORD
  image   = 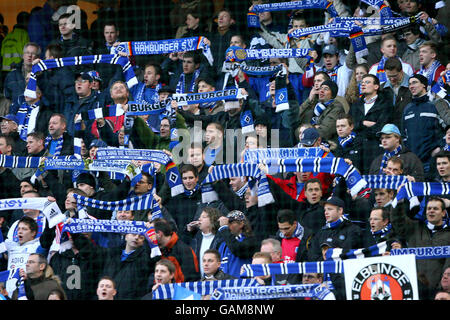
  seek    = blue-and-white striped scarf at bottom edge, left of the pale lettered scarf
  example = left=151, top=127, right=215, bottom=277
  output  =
left=152, top=279, right=260, bottom=300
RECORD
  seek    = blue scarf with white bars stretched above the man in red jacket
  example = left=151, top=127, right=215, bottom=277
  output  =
left=263, top=157, right=367, bottom=196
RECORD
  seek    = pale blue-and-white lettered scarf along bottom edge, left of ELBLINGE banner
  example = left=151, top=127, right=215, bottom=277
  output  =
left=211, top=283, right=330, bottom=300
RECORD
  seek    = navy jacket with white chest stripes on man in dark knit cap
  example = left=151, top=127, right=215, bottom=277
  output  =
left=402, top=95, right=444, bottom=164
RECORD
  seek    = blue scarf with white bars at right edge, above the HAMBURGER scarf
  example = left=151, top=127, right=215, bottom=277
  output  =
left=392, top=182, right=450, bottom=208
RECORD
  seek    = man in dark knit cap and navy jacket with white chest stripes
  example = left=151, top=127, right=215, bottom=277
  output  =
left=402, top=74, right=443, bottom=173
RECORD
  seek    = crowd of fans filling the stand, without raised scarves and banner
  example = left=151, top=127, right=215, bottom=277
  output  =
left=0, top=0, right=450, bottom=300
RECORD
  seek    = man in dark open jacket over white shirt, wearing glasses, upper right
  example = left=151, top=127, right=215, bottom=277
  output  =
left=350, top=74, right=393, bottom=174
